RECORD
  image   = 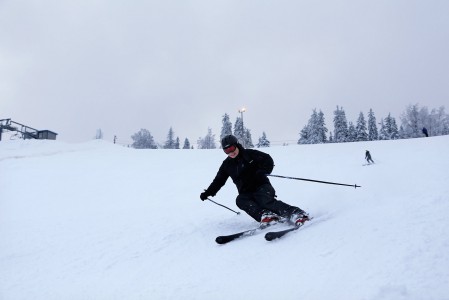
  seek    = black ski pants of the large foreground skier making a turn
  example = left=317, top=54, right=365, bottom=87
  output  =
left=236, top=184, right=299, bottom=222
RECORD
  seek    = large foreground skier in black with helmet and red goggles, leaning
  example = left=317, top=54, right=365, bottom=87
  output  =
left=200, top=135, right=309, bottom=226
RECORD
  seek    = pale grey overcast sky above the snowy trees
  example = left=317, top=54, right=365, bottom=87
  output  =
left=0, top=0, right=449, bottom=147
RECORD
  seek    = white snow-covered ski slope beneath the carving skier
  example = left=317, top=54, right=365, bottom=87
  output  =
left=0, top=136, right=449, bottom=300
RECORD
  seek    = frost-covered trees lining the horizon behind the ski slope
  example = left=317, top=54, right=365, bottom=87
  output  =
left=131, top=104, right=449, bottom=149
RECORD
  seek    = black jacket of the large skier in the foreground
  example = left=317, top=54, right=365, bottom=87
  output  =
left=206, top=145, right=274, bottom=196
